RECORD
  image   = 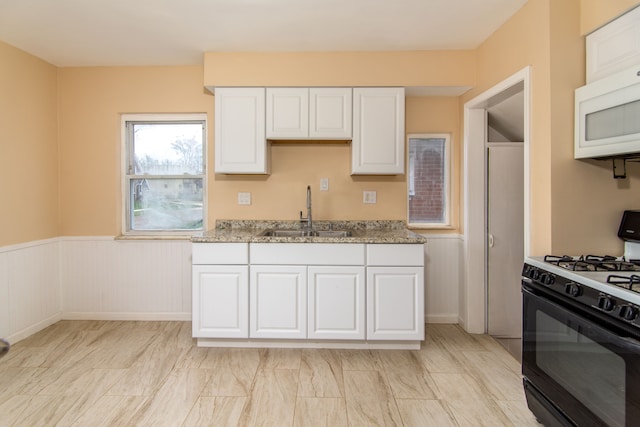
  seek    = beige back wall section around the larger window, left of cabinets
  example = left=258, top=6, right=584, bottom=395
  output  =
left=59, top=66, right=213, bottom=236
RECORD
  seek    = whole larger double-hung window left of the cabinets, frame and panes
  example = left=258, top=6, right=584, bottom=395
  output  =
left=122, top=114, right=207, bottom=234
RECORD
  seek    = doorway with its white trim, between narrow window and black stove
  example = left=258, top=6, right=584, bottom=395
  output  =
left=460, top=67, right=530, bottom=357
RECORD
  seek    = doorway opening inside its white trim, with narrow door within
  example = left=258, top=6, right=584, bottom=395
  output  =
left=485, top=82, right=524, bottom=358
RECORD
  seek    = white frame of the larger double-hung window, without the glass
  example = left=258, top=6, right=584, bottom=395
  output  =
left=120, top=113, right=208, bottom=238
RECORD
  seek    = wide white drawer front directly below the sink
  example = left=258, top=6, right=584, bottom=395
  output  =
left=251, top=243, right=364, bottom=265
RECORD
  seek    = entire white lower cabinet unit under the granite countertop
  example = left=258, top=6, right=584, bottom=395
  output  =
left=192, top=243, right=424, bottom=342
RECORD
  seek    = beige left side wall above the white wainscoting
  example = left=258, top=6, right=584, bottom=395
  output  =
left=0, top=42, right=60, bottom=246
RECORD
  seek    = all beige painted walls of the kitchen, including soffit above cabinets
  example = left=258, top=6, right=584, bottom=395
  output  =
left=7, top=0, right=640, bottom=246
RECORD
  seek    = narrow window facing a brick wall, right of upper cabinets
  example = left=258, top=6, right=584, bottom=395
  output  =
left=407, top=134, right=451, bottom=228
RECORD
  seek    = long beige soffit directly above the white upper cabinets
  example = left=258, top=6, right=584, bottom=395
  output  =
left=204, top=50, right=475, bottom=86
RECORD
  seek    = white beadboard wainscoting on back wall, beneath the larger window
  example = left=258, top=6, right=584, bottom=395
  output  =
left=61, top=237, right=191, bottom=320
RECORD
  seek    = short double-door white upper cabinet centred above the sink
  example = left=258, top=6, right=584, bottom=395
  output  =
left=266, top=88, right=352, bottom=140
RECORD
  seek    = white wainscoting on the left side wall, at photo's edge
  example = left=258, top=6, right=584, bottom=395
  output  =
left=0, top=239, right=61, bottom=343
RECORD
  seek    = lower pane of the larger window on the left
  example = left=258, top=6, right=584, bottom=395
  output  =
left=130, top=178, right=203, bottom=230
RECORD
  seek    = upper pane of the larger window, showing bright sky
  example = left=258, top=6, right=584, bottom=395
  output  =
left=133, top=122, right=203, bottom=175
